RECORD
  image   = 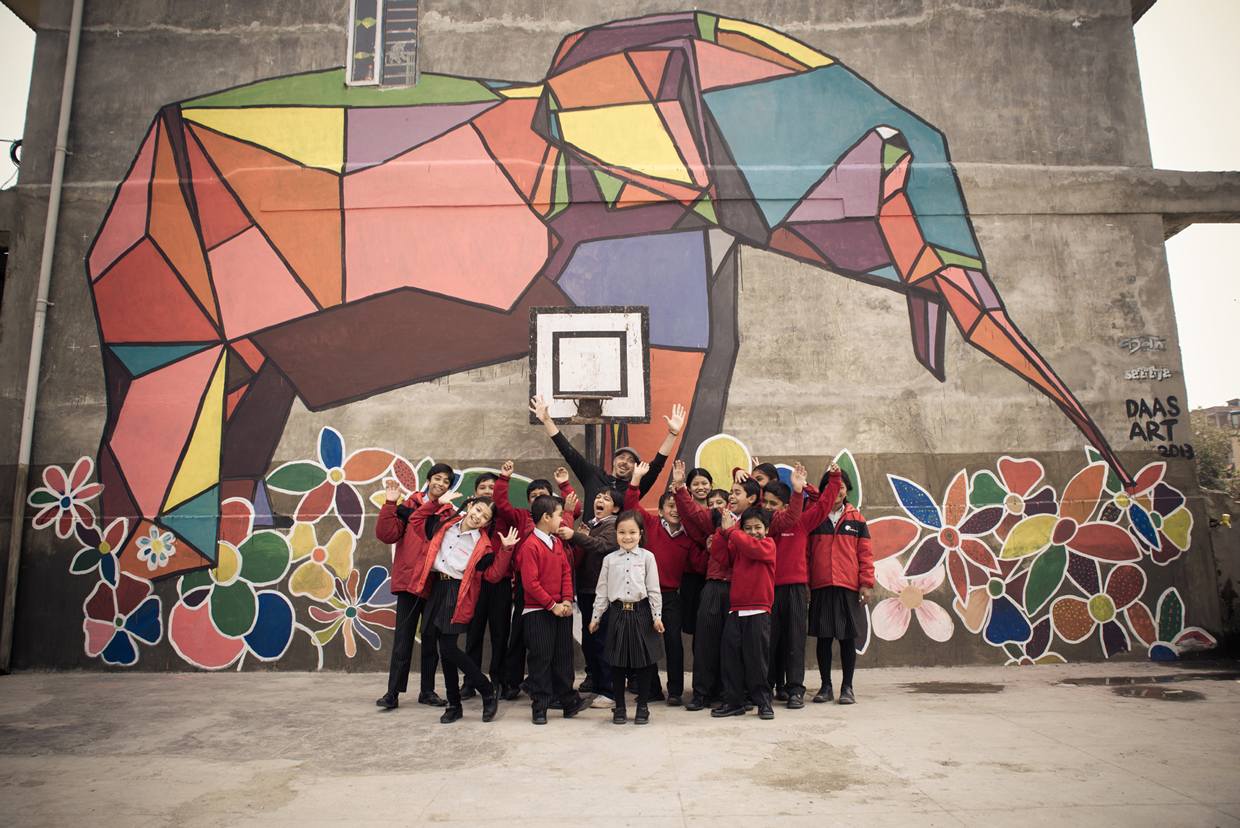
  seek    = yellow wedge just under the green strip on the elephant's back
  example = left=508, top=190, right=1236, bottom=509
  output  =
left=182, top=107, right=345, bottom=172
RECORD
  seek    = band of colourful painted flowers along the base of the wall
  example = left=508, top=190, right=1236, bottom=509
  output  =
left=30, top=428, right=1216, bottom=669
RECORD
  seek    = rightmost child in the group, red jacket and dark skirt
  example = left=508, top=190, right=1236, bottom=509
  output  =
left=810, top=464, right=874, bottom=704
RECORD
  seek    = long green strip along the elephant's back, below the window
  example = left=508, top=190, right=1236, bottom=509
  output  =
left=181, top=68, right=500, bottom=109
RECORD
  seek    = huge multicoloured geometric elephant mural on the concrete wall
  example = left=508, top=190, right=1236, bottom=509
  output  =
left=82, top=12, right=1133, bottom=575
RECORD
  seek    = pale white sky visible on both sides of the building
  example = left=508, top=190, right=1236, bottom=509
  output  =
left=0, top=0, right=1240, bottom=408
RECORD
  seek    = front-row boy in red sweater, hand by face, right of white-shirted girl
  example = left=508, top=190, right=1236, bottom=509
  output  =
left=711, top=507, right=775, bottom=719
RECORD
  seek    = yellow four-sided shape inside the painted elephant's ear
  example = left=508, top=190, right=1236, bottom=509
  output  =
left=559, top=104, right=693, bottom=186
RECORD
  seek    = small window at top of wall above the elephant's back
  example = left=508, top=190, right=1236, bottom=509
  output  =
left=346, top=0, right=418, bottom=87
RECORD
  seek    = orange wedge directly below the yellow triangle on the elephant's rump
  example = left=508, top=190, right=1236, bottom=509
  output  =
left=190, top=125, right=343, bottom=307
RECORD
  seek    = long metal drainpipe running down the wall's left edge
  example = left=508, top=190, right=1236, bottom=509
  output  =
left=0, top=0, right=84, bottom=673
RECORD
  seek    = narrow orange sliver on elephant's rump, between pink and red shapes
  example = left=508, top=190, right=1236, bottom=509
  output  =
left=149, top=125, right=219, bottom=322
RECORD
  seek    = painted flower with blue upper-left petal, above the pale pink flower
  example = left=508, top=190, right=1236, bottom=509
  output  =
left=887, top=471, right=1003, bottom=582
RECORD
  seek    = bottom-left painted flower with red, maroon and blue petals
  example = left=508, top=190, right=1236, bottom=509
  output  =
left=82, top=570, right=164, bottom=667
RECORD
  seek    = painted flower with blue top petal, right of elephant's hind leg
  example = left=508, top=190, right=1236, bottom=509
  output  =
left=267, top=426, right=396, bottom=538
